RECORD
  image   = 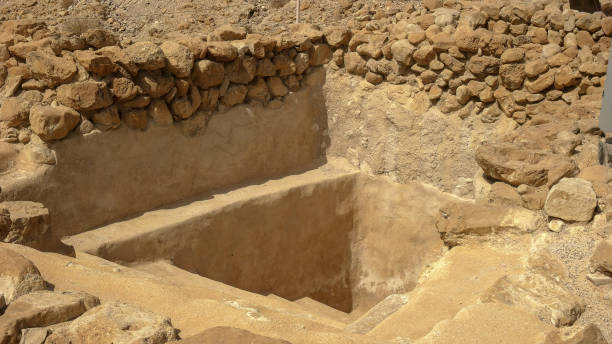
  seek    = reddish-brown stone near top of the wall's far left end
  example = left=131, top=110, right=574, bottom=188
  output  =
left=26, top=51, right=77, bottom=88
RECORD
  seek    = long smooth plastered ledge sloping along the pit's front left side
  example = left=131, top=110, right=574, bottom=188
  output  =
left=0, top=243, right=381, bottom=344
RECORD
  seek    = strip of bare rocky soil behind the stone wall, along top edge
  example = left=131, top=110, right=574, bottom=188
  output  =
left=0, top=0, right=421, bottom=42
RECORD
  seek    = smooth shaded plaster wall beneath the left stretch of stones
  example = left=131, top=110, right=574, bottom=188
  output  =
left=0, top=69, right=329, bottom=245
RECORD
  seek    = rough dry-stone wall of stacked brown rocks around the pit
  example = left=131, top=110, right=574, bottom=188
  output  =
left=0, top=0, right=612, bottom=143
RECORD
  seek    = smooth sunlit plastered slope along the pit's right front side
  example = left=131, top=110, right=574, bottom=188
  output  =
left=368, top=245, right=524, bottom=343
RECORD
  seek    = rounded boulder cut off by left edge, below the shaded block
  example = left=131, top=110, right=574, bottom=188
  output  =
left=0, top=247, right=47, bottom=306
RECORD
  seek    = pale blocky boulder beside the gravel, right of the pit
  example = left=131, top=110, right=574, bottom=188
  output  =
left=544, top=178, right=597, bottom=221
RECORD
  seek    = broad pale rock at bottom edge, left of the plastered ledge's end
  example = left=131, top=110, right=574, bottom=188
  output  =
left=45, top=302, right=177, bottom=344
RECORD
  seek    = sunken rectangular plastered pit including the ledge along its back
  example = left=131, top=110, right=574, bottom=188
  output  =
left=64, top=164, right=452, bottom=312
